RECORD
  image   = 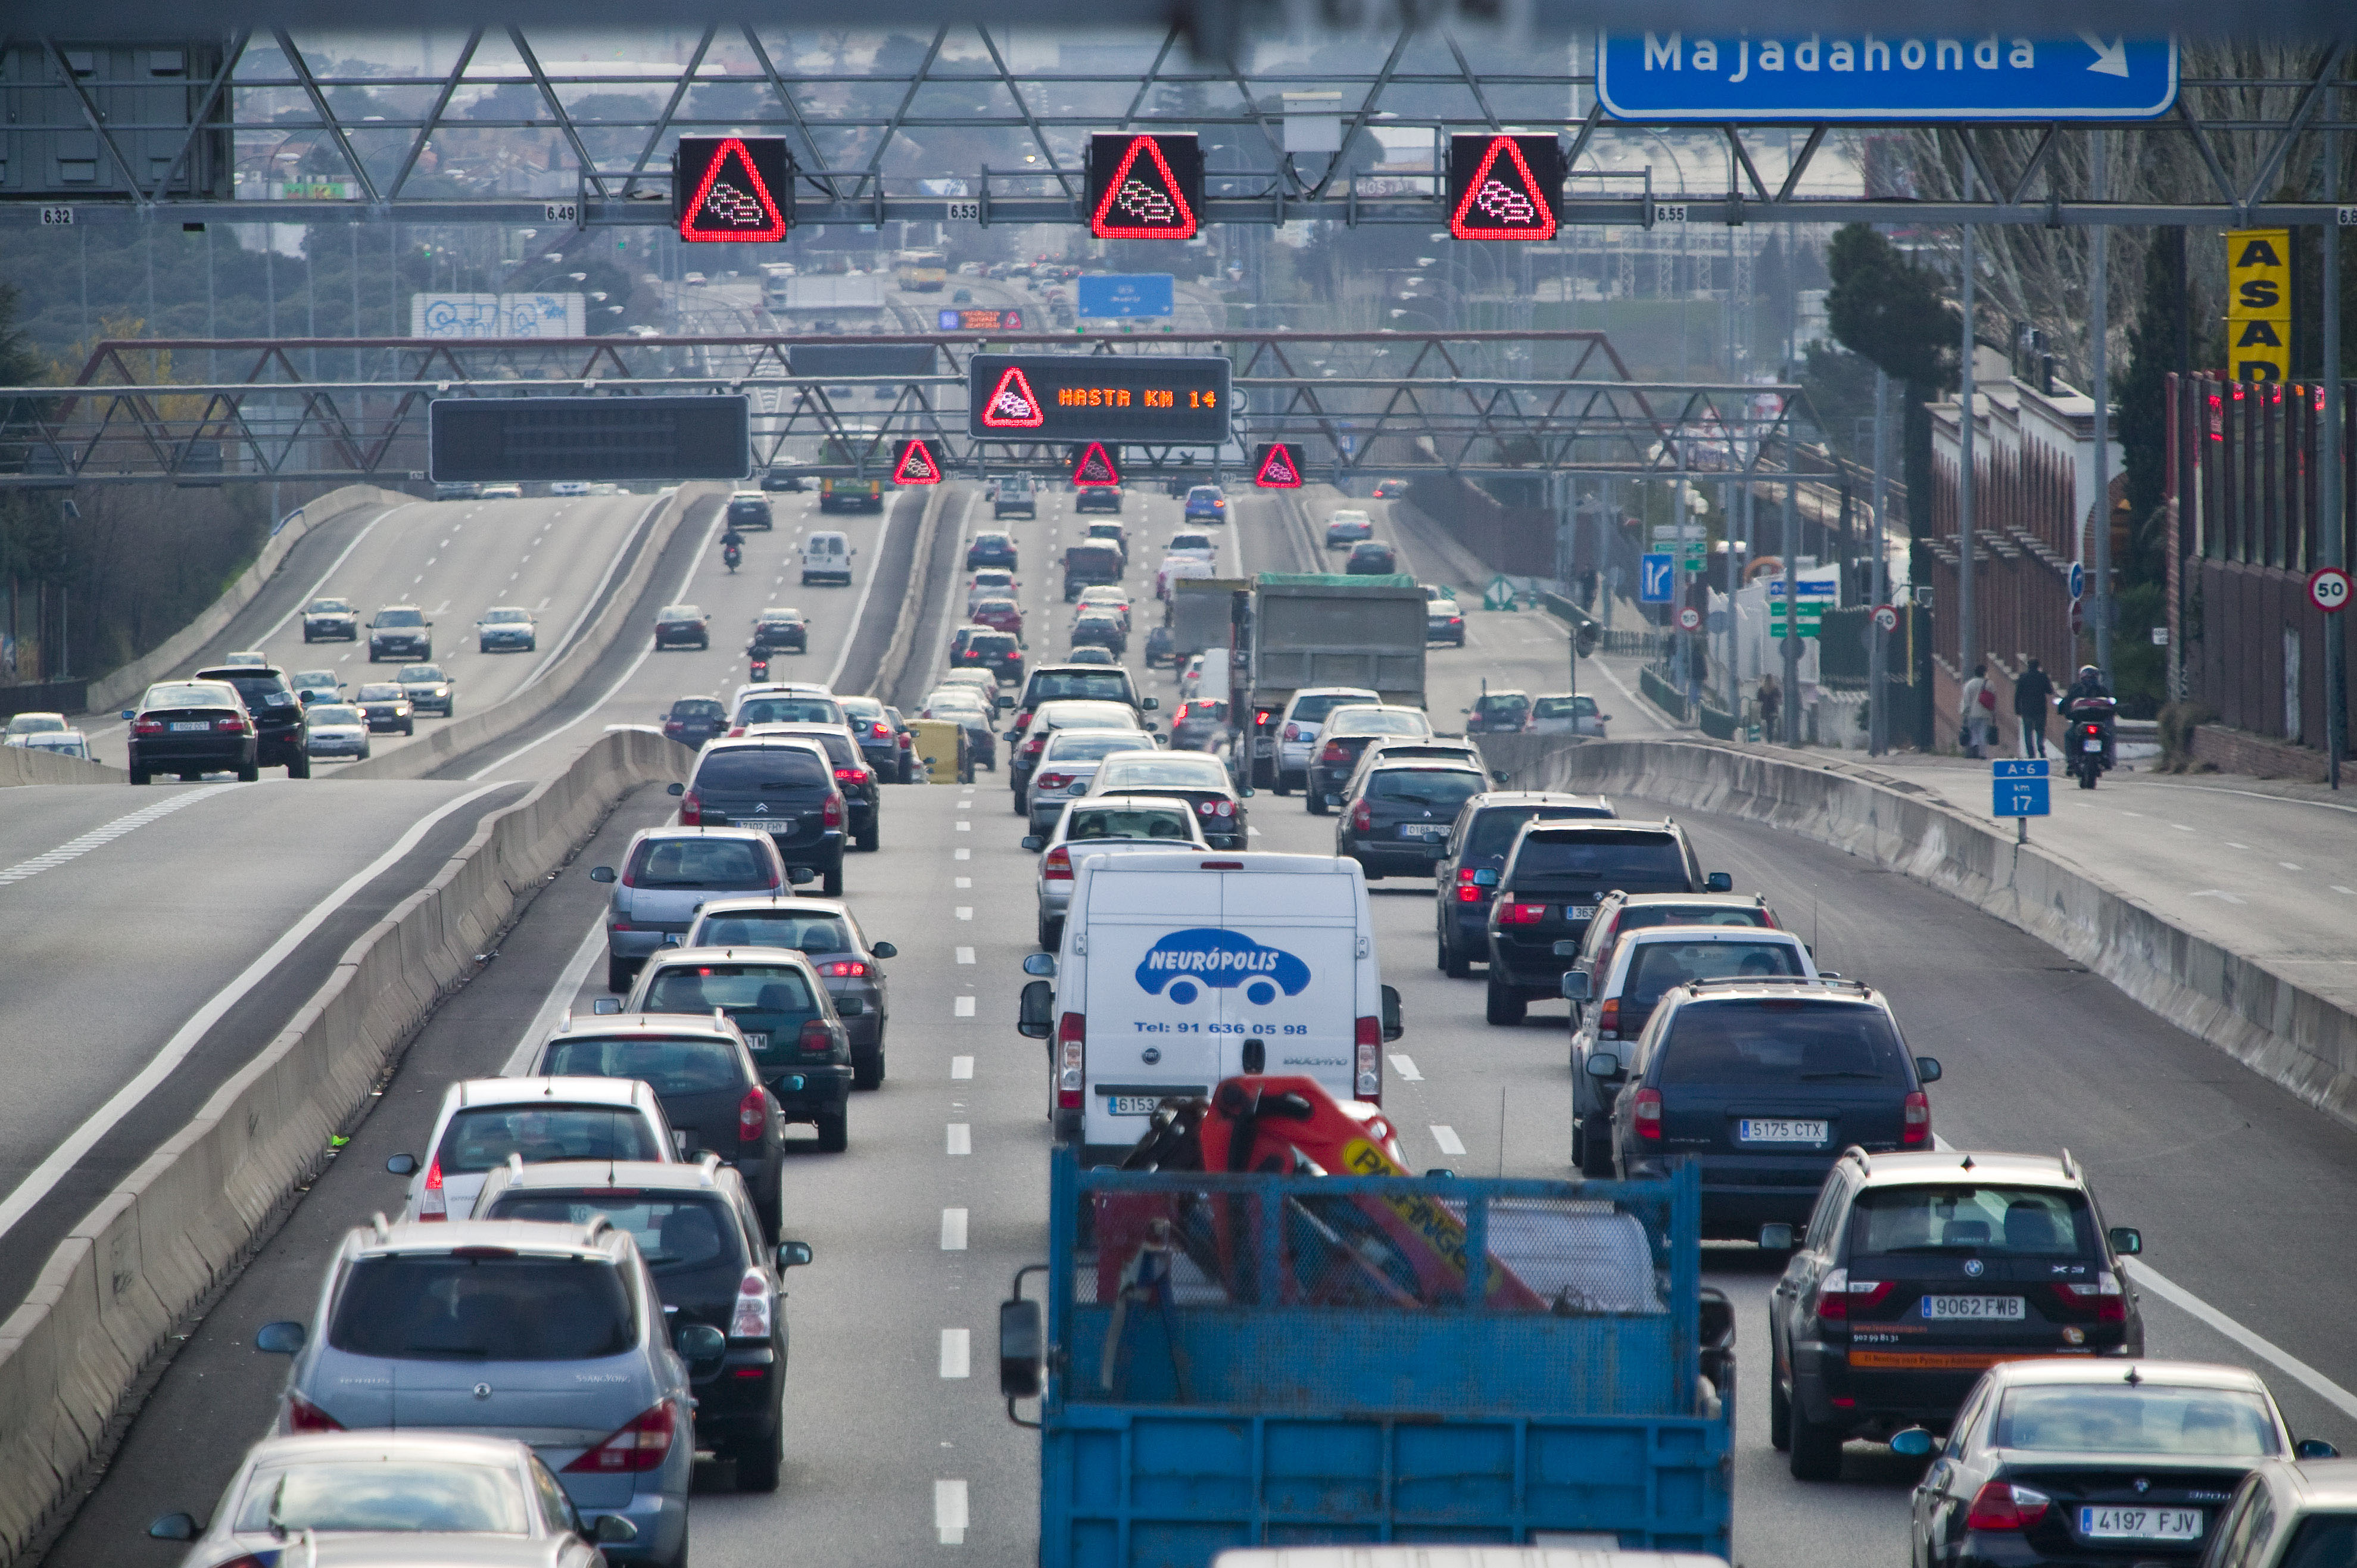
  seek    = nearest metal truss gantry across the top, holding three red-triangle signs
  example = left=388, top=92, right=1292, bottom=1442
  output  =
left=0, top=27, right=2357, bottom=226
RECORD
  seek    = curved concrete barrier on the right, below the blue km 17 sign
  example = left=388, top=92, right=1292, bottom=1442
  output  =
left=1483, top=735, right=2357, bottom=1125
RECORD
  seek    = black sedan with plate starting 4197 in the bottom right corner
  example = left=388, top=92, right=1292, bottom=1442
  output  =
left=1895, top=1356, right=2319, bottom=1568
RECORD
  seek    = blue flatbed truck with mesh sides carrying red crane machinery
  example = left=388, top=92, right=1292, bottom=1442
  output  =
left=999, top=1148, right=1735, bottom=1568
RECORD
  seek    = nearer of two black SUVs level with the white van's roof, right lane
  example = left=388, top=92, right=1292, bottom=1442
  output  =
left=1483, top=818, right=1735, bottom=1023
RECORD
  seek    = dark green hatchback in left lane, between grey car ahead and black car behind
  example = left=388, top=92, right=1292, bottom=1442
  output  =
left=617, top=948, right=863, bottom=1153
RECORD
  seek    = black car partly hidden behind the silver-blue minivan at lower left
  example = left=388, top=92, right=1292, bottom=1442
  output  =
left=481, top=1160, right=811, bottom=1492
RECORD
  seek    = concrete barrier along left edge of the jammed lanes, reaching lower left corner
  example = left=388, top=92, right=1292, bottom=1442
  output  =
left=0, top=731, right=688, bottom=1563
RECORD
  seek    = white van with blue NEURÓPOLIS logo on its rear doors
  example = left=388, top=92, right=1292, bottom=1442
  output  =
left=1018, top=851, right=1400, bottom=1162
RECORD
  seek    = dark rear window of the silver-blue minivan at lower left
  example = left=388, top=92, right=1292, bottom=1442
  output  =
left=328, top=1245, right=639, bottom=1361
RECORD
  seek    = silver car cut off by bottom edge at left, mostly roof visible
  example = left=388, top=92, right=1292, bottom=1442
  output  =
left=148, top=1431, right=637, bottom=1568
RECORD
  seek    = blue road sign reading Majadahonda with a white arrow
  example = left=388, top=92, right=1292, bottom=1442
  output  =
left=1596, top=32, right=2178, bottom=123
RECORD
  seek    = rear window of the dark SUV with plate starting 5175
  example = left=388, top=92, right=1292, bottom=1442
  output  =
left=1659, top=997, right=1909, bottom=1089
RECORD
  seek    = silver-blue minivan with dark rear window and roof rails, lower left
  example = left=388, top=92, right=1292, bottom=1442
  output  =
left=254, top=1214, right=702, bottom=1568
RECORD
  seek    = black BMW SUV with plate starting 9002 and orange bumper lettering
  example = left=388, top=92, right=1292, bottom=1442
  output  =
left=1763, top=1148, right=2159, bottom=1480
